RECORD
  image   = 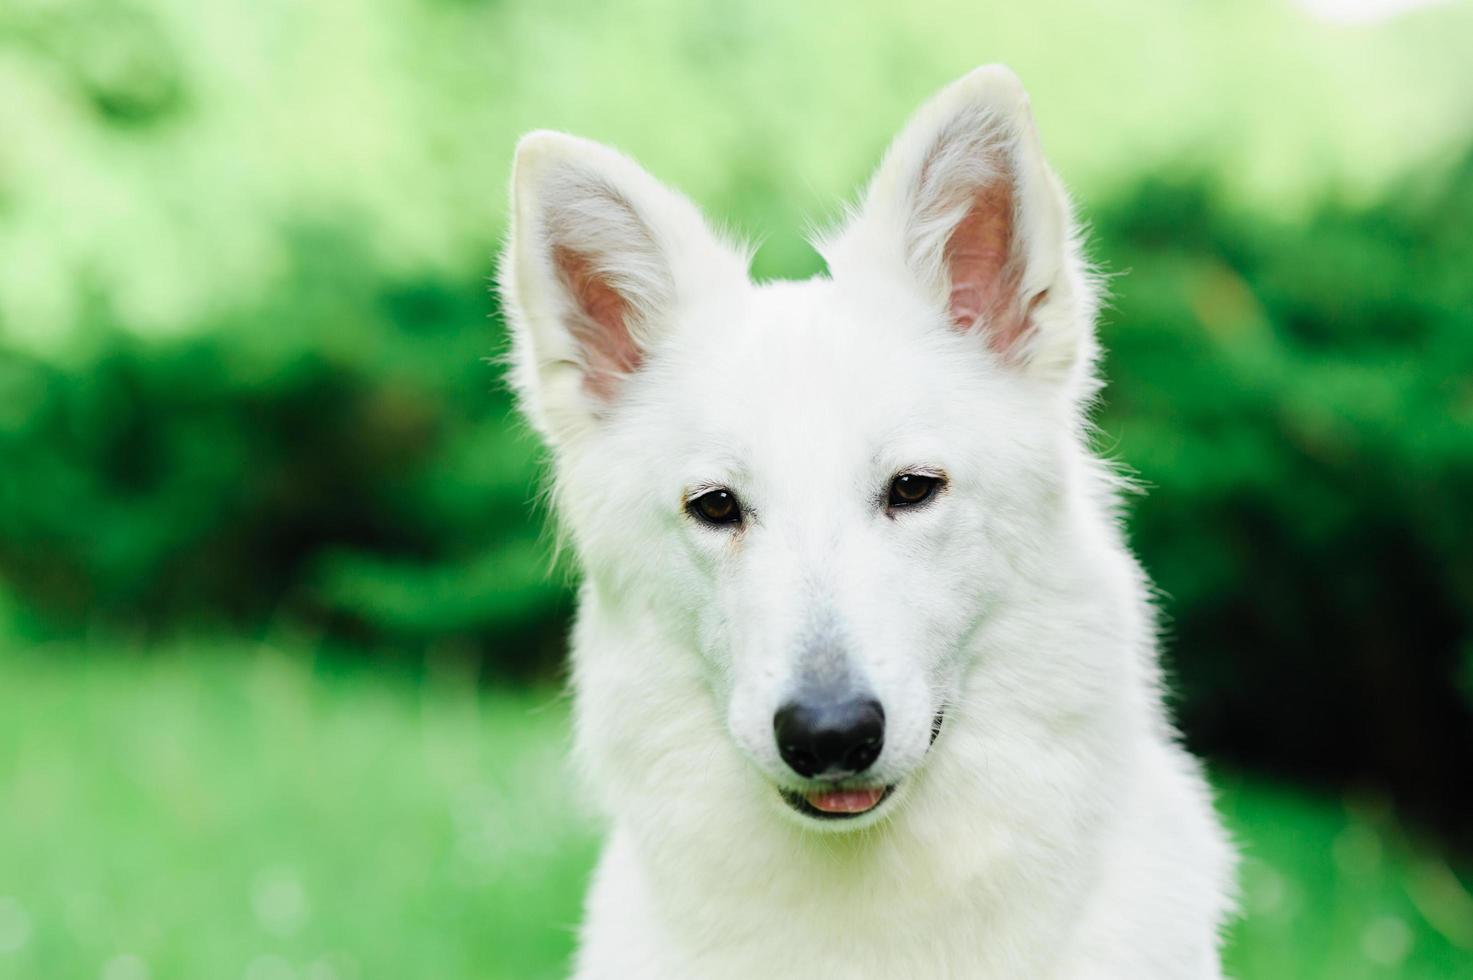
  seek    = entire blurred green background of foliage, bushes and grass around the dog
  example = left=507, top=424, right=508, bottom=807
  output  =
left=0, top=0, right=1473, bottom=980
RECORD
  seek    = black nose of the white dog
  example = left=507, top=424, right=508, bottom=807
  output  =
left=772, top=697, right=885, bottom=778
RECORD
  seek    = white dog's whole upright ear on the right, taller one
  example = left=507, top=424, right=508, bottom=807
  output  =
left=820, top=65, right=1094, bottom=383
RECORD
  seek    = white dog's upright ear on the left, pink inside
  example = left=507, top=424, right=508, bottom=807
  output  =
left=498, top=131, right=747, bottom=447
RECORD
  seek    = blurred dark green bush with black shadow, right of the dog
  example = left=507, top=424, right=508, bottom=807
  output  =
left=1097, top=161, right=1473, bottom=824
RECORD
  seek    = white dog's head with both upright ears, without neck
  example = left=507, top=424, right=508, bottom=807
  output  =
left=502, top=69, right=1093, bottom=828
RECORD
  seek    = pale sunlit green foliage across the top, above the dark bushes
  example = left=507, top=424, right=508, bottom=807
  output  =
left=0, top=0, right=1473, bottom=351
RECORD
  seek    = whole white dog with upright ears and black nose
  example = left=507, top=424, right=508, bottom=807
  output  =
left=501, top=66, right=1233, bottom=980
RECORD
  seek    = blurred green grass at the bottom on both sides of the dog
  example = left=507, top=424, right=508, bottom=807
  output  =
left=0, top=644, right=1473, bottom=980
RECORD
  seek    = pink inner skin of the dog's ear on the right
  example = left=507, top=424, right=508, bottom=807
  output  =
left=946, top=178, right=1028, bottom=354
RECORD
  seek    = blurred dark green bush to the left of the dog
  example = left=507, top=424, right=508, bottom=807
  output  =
left=0, top=230, right=566, bottom=671
